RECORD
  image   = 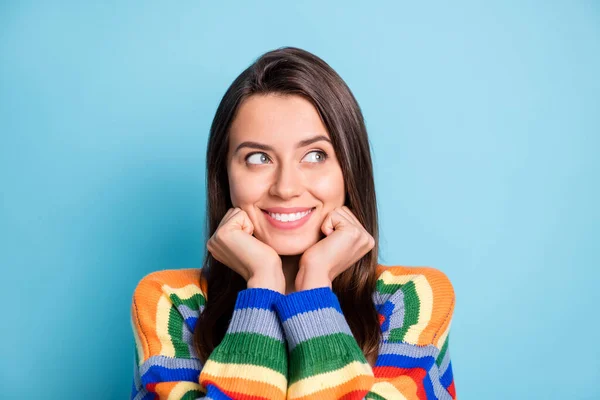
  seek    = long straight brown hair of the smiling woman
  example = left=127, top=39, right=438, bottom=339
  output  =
left=194, top=47, right=381, bottom=363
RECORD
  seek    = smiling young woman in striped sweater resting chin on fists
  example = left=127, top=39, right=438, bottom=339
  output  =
left=132, top=47, right=456, bottom=400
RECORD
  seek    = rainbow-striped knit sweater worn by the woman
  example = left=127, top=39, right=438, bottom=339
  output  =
left=131, top=265, right=456, bottom=400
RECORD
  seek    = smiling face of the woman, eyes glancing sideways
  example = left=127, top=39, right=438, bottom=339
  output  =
left=227, top=94, right=345, bottom=255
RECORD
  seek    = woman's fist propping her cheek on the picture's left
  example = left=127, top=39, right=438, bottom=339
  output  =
left=206, top=207, right=285, bottom=293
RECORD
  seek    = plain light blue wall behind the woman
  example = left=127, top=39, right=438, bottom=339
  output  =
left=0, top=1, right=600, bottom=400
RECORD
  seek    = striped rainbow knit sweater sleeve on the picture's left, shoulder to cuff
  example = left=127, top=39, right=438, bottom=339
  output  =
left=131, top=274, right=287, bottom=400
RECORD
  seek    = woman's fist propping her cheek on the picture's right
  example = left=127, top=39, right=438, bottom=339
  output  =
left=295, top=206, right=375, bottom=291
